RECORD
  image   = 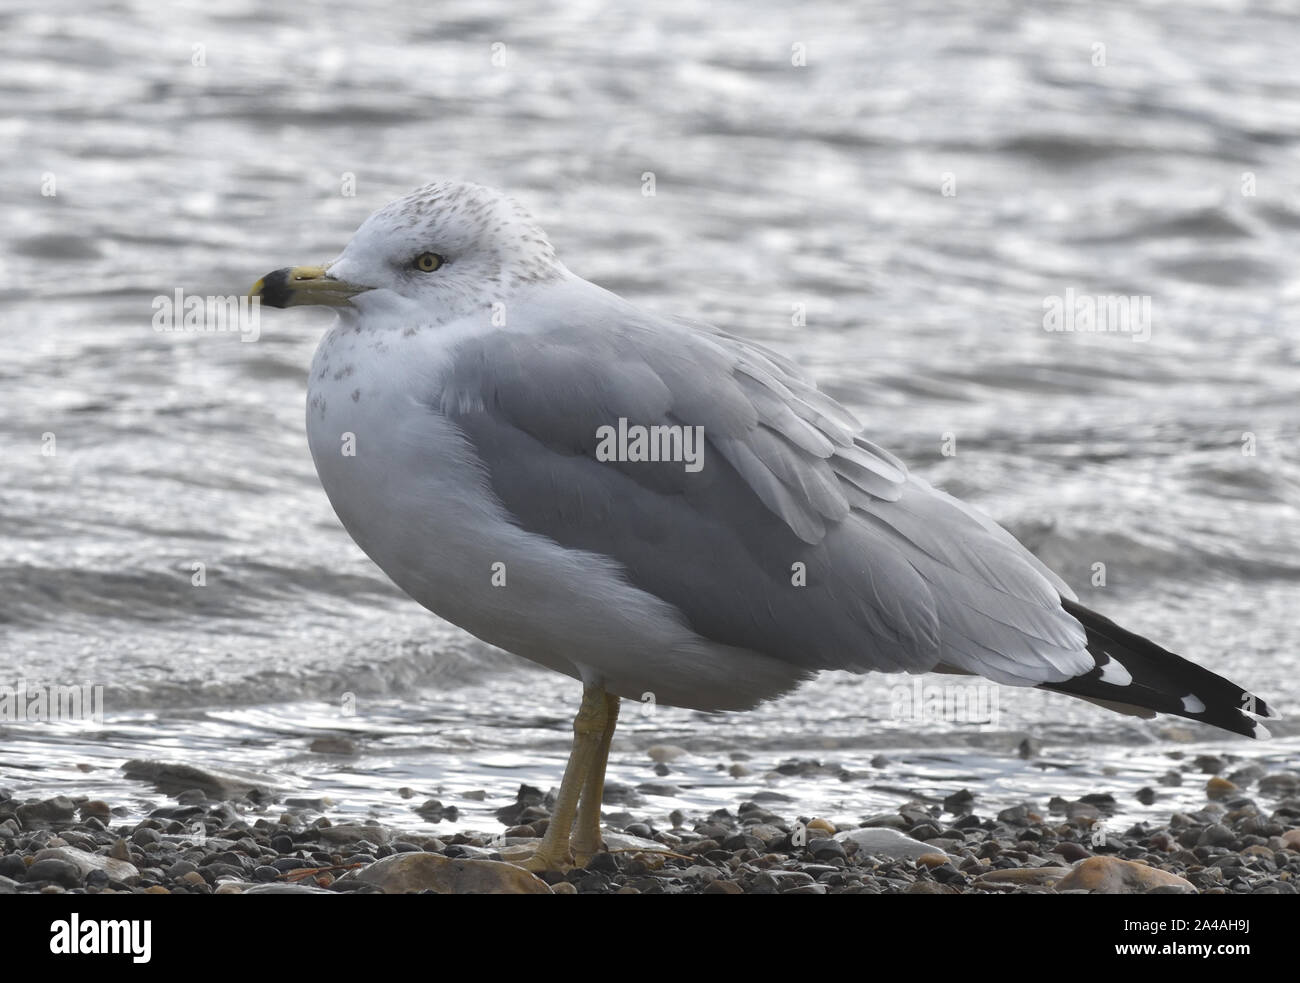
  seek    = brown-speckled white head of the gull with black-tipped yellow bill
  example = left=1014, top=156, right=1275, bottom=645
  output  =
left=250, top=181, right=564, bottom=324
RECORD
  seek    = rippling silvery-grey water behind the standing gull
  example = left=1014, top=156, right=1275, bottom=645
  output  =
left=0, top=0, right=1300, bottom=831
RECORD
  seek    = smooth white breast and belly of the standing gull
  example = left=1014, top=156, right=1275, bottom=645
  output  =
left=307, top=310, right=800, bottom=710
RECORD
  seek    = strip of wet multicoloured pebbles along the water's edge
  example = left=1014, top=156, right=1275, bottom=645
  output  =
left=0, top=755, right=1300, bottom=895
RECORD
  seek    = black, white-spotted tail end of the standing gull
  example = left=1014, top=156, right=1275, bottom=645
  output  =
left=1040, top=599, right=1277, bottom=737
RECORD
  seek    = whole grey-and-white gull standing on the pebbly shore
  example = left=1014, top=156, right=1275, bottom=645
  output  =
left=251, top=181, right=1273, bottom=870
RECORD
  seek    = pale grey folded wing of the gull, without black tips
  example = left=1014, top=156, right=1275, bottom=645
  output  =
left=436, top=307, right=1093, bottom=684
